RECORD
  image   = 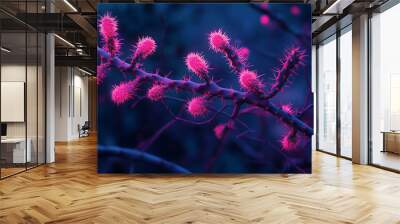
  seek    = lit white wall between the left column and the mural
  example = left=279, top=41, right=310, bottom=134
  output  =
left=55, top=67, right=89, bottom=141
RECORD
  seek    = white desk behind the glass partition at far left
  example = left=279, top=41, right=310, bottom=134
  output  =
left=1, top=138, right=32, bottom=163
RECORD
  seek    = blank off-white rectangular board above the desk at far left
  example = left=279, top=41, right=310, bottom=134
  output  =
left=1, top=82, right=25, bottom=122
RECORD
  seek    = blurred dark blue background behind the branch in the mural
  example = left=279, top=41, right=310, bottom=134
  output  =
left=98, top=4, right=312, bottom=173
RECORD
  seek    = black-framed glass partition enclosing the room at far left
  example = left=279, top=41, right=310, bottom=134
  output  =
left=0, top=1, right=46, bottom=179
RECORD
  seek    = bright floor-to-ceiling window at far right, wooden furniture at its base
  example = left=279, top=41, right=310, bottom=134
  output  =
left=370, top=4, right=400, bottom=170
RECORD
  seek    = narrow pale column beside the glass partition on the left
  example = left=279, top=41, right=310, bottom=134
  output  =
left=46, top=1, right=55, bottom=163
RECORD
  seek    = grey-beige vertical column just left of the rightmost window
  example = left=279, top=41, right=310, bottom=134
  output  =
left=352, top=15, right=368, bottom=164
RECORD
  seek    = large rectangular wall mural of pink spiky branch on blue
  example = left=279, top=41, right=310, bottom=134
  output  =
left=97, top=3, right=313, bottom=174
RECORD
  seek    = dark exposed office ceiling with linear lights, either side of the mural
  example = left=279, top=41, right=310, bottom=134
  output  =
left=0, top=0, right=387, bottom=75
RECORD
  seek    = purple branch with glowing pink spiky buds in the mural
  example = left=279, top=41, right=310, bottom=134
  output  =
left=97, top=15, right=313, bottom=149
